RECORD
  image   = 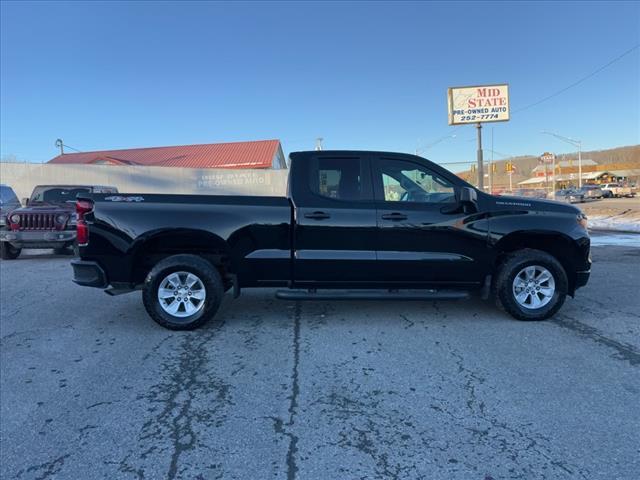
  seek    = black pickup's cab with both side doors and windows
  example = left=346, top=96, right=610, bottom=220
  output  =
left=289, top=152, right=489, bottom=288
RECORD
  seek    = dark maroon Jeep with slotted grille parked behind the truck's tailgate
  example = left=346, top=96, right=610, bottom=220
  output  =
left=0, top=185, right=118, bottom=260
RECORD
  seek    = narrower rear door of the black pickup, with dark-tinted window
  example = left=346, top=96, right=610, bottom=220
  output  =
left=291, top=152, right=377, bottom=288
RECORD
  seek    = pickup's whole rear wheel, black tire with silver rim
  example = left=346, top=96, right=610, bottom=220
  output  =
left=142, top=255, right=224, bottom=330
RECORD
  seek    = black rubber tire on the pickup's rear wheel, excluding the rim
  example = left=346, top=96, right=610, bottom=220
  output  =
left=142, top=254, right=224, bottom=330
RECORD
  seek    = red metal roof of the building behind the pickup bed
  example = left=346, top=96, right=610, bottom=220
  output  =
left=49, top=140, right=287, bottom=169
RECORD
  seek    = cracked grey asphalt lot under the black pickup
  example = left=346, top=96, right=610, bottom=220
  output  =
left=0, top=247, right=640, bottom=480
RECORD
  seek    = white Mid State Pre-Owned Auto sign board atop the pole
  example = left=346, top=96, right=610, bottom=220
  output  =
left=448, top=84, right=509, bottom=125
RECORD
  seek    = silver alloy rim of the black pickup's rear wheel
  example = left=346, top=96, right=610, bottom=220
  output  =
left=158, top=272, right=207, bottom=318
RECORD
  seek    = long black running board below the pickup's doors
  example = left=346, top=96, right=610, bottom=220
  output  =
left=276, top=289, right=469, bottom=300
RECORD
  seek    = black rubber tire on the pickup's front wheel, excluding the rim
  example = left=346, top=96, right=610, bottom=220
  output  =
left=495, top=249, right=568, bottom=321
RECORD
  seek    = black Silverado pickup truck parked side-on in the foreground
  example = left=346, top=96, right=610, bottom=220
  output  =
left=72, top=151, right=591, bottom=329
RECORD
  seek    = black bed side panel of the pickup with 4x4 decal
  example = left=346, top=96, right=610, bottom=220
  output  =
left=78, top=193, right=292, bottom=285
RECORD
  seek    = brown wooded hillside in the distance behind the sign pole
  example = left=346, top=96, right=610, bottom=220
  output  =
left=458, top=145, right=640, bottom=188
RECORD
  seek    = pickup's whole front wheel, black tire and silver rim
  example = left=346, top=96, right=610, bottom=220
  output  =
left=496, top=249, right=568, bottom=320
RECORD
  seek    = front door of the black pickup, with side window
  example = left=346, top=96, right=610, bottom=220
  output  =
left=373, top=156, right=489, bottom=287
